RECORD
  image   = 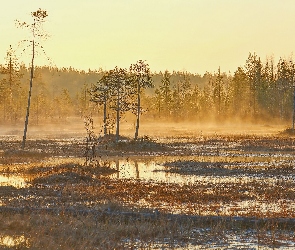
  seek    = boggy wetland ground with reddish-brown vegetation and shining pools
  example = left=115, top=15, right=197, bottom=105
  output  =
left=0, top=124, right=295, bottom=249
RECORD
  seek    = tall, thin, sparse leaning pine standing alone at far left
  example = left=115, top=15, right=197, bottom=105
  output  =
left=17, top=8, right=48, bottom=149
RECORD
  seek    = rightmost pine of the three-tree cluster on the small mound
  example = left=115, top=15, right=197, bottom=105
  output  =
left=130, top=60, right=153, bottom=140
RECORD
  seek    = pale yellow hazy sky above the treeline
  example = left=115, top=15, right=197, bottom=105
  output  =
left=0, top=0, right=295, bottom=74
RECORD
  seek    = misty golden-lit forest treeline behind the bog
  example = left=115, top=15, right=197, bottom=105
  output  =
left=0, top=53, right=295, bottom=127
